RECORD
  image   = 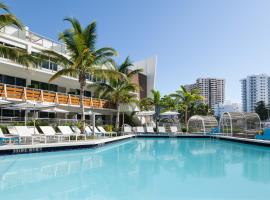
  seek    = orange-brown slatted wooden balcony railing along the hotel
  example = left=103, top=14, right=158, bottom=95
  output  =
left=0, top=83, right=115, bottom=109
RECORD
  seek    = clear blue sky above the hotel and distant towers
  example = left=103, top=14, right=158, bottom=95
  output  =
left=5, top=0, right=270, bottom=102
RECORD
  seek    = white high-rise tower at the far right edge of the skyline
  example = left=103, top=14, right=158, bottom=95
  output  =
left=240, top=74, right=270, bottom=112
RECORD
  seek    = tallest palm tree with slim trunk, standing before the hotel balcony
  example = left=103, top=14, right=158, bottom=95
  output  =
left=43, top=18, right=119, bottom=131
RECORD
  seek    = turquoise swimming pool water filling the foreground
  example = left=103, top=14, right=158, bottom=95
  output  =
left=0, top=139, right=270, bottom=200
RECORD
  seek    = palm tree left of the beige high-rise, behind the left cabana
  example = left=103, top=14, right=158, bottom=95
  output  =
left=170, top=86, right=203, bottom=124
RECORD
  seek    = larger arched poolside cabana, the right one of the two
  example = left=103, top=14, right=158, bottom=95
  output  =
left=219, top=112, right=261, bottom=138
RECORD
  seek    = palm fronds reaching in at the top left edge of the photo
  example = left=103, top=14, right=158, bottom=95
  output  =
left=0, top=3, right=38, bottom=67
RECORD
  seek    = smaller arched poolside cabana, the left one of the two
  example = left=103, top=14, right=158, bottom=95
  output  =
left=187, top=115, right=218, bottom=134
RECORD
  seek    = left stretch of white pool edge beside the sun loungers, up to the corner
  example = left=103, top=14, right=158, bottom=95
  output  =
left=0, top=134, right=134, bottom=155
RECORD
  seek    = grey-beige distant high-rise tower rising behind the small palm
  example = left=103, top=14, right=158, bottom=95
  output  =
left=184, top=78, right=225, bottom=108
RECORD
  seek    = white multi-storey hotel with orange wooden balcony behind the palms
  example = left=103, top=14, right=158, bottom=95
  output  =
left=0, top=27, right=156, bottom=121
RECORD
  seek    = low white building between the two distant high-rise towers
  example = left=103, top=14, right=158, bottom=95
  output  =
left=213, top=101, right=242, bottom=117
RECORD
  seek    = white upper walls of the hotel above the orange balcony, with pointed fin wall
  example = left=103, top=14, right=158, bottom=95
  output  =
left=0, top=26, right=156, bottom=101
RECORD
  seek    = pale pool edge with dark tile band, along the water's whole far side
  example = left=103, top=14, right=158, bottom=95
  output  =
left=0, top=134, right=270, bottom=155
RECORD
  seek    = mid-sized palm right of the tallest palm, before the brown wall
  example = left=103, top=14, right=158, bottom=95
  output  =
left=90, top=57, right=142, bottom=130
